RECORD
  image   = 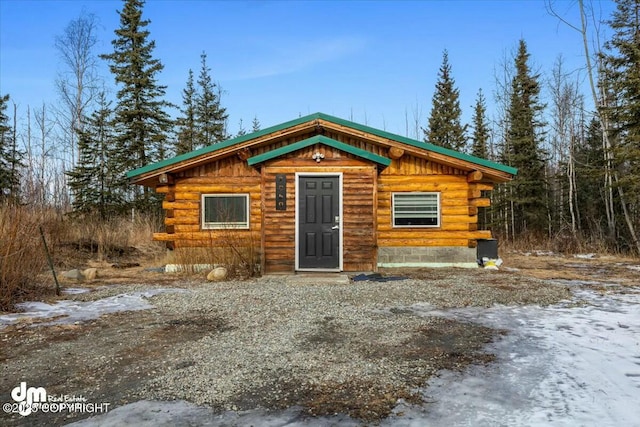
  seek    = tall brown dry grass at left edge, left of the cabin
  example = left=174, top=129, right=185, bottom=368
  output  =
left=0, top=205, right=164, bottom=311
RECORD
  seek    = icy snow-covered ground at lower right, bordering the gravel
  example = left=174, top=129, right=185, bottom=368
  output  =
left=56, top=281, right=640, bottom=427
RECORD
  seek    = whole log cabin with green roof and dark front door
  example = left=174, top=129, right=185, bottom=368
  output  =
left=127, top=113, right=517, bottom=273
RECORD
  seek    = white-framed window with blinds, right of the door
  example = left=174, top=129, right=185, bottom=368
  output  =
left=392, top=193, right=440, bottom=227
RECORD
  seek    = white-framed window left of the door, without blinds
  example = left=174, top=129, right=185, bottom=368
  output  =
left=201, top=194, right=249, bottom=229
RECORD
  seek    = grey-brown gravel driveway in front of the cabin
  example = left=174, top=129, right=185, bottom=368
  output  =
left=0, top=269, right=570, bottom=425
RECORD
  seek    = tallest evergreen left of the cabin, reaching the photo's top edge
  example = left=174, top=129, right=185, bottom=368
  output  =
left=101, top=0, right=171, bottom=208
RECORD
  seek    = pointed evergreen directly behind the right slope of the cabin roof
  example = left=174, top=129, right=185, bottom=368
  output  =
left=423, top=50, right=466, bottom=151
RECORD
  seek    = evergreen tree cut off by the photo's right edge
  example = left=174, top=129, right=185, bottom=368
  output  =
left=604, top=0, right=640, bottom=253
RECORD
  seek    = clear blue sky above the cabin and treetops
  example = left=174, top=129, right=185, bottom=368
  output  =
left=0, top=0, right=615, bottom=137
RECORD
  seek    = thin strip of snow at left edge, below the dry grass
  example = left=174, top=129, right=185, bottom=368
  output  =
left=0, top=288, right=187, bottom=328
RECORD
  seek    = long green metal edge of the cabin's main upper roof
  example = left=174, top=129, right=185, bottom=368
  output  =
left=127, top=113, right=518, bottom=179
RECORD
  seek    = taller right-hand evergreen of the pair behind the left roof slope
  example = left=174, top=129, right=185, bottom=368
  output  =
left=195, top=52, right=227, bottom=147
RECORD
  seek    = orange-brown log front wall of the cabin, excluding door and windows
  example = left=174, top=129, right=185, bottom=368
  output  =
left=154, top=129, right=493, bottom=273
